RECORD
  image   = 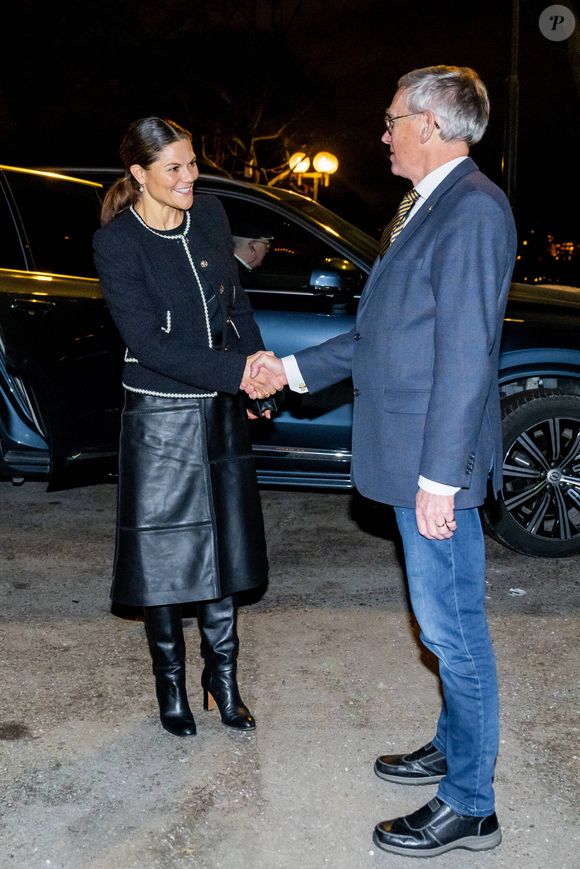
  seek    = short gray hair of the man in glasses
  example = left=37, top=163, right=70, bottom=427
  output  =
left=397, top=66, right=489, bottom=145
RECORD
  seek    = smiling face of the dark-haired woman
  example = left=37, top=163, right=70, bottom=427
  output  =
left=131, top=139, right=199, bottom=210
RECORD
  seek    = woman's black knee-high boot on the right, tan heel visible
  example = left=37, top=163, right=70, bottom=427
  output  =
left=197, top=595, right=256, bottom=730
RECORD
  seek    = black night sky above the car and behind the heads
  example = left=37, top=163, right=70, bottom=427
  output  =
left=0, top=0, right=580, bottom=256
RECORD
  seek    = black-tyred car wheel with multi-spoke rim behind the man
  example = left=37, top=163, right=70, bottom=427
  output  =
left=484, top=390, right=580, bottom=558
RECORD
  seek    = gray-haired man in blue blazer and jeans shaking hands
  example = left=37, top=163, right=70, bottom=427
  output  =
left=255, top=66, right=516, bottom=856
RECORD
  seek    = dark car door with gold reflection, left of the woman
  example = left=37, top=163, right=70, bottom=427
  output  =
left=0, top=168, right=122, bottom=489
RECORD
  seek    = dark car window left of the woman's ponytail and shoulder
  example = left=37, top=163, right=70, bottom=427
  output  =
left=6, top=172, right=100, bottom=277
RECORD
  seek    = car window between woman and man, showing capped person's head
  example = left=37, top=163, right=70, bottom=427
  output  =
left=219, top=194, right=366, bottom=312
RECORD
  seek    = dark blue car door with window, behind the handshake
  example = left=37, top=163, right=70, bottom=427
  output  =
left=212, top=192, right=366, bottom=487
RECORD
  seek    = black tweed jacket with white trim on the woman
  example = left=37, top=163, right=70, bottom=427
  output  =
left=93, top=195, right=264, bottom=398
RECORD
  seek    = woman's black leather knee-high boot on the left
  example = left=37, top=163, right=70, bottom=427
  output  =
left=143, top=605, right=196, bottom=736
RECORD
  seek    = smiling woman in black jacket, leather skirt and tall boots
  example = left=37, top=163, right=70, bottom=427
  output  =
left=94, top=117, right=281, bottom=736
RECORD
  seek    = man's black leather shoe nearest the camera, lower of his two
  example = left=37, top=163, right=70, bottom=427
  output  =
left=373, top=797, right=501, bottom=857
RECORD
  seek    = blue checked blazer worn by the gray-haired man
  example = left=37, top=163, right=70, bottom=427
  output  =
left=296, top=158, right=517, bottom=509
